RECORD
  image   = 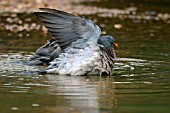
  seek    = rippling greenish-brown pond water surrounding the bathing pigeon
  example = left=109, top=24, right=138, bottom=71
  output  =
left=0, top=0, right=170, bottom=113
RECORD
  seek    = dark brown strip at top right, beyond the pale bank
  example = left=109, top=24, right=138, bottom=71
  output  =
left=83, top=0, right=170, bottom=13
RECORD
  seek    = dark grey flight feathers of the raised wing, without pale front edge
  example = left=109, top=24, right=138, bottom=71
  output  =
left=34, top=8, right=98, bottom=48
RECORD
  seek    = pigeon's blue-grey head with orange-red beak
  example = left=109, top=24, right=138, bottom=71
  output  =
left=98, top=36, right=118, bottom=48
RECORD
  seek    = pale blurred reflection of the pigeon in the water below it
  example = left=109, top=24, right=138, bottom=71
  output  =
left=46, top=75, right=117, bottom=113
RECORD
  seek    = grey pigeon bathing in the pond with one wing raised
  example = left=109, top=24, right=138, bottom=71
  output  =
left=29, top=8, right=118, bottom=75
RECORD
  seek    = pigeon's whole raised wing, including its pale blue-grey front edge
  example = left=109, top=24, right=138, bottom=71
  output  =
left=34, top=8, right=101, bottom=49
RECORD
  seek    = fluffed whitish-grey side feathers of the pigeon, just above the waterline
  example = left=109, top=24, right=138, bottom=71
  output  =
left=47, top=45, right=102, bottom=75
